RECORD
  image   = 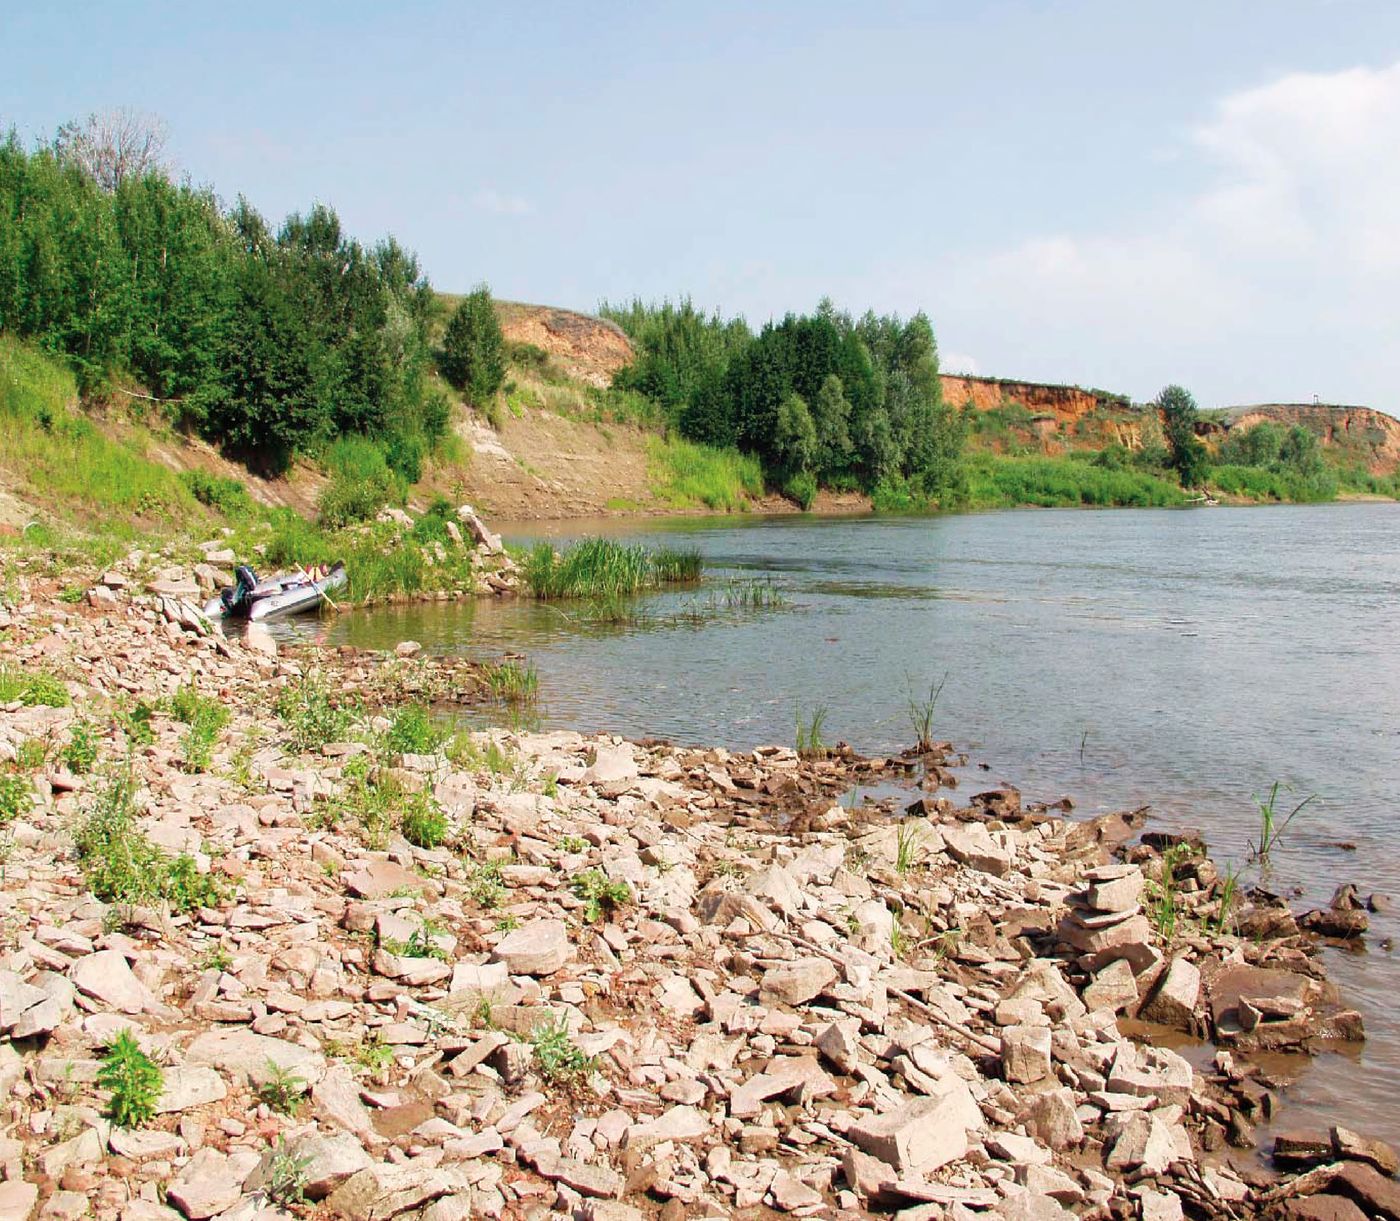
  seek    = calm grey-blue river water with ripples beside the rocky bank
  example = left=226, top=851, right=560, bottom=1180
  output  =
left=287, top=504, right=1400, bottom=1141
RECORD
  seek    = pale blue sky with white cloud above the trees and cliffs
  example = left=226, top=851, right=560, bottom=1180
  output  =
left=8, top=0, right=1400, bottom=413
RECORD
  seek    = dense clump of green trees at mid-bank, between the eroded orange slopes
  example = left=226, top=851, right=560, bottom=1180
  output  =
left=601, top=300, right=965, bottom=504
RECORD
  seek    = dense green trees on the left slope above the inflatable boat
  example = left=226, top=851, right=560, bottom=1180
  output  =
left=0, top=116, right=449, bottom=480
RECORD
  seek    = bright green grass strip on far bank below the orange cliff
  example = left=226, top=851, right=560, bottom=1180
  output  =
left=967, top=454, right=1186, bottom=508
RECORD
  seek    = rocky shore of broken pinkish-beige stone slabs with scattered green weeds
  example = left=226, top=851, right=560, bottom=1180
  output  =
left=0, top=577, right=1400, bottom=1221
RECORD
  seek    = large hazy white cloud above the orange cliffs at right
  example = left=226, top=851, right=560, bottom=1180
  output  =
left=939, top=64, right=1400, bottom=409
